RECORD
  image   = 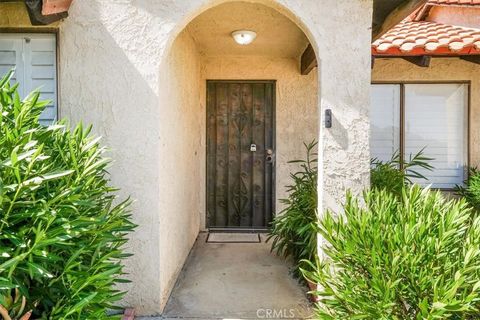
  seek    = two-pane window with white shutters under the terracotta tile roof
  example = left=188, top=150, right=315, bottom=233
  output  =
left=370, top=83, right=469, bottom=189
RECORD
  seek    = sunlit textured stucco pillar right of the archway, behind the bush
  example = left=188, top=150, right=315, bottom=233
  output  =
left=312, top=0, right=372, bottom=214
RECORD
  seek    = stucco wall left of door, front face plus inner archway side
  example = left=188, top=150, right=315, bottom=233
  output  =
left=60, top=1, right=201, bottom=314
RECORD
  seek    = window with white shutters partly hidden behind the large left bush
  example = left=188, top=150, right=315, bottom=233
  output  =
left=0, top=33, right=57, bottom=124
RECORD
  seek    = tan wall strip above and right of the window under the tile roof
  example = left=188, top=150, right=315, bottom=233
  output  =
left=372, top=58, right=480, bottom=166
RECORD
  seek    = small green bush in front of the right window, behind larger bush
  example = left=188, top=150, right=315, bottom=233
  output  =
left=370, top=149, right=433, bottom=195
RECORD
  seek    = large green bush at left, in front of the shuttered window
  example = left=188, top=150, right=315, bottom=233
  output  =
left=0, top=73, right=134, bottom=319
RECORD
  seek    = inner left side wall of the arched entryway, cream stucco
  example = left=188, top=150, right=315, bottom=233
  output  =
left=157, top=32, right=205, bottom=303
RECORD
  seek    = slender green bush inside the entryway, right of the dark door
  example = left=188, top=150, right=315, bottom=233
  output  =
left=267, top=142, right=318, bottom=274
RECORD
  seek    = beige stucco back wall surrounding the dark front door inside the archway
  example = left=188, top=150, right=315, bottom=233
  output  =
left=201, top=56, right=320, bottom=225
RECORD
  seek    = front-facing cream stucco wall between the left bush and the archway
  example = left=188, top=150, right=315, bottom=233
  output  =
left=59, top=1, right=195, bottom=313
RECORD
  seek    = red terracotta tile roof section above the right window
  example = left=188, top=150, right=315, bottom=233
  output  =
left=372, top=20, right=480, bottom=56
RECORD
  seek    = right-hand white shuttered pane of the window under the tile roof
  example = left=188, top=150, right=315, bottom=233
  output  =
left=405, top=84, right=468, bottom=189
